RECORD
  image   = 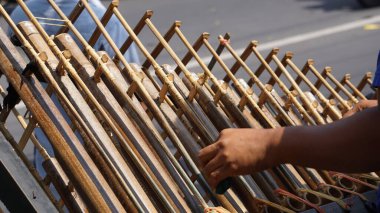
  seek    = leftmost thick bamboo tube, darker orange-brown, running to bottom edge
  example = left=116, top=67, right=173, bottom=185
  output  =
left=0, top=18, right=109, bottom=211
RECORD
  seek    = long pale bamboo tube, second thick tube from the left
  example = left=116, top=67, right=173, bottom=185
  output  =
left=19, top=22, right=144, bottom=211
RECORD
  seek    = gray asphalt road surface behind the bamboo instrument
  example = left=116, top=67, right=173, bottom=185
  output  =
left=1, top=0, right=380, bottom=158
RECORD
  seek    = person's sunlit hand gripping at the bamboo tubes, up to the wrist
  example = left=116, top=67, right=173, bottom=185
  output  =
left=199, top=129, right=279, bottom=188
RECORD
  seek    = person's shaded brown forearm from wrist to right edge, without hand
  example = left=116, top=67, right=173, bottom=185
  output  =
left=273, top=107, right=380, bottom=172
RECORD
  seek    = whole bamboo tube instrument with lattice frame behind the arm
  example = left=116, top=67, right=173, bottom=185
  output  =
left=0, top=0, right=380, bottom=212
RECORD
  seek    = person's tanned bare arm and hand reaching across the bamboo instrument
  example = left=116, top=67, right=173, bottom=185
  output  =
left=199, top=108, right=380, bottom=187
